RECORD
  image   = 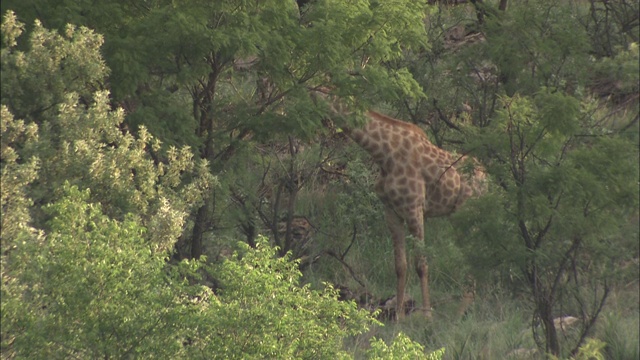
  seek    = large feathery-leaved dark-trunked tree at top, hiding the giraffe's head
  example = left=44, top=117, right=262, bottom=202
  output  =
left=3, top=0, right=432, bottom=257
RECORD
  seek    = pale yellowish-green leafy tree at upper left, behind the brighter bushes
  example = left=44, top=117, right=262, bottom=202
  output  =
left=2, top=13, right=214, bottom=252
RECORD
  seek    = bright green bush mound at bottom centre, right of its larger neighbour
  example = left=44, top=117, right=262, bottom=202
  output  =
left=192, top=238, right=374, bottom=359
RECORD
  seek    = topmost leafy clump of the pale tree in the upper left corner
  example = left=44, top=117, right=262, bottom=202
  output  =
left=2, top=11, right=108, bottom=121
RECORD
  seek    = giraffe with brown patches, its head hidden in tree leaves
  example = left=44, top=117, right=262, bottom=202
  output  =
left=343, top=111, right=485, bottom=319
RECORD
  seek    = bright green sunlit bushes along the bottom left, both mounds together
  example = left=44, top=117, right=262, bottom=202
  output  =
left=2, top=185, right=382, bottom=359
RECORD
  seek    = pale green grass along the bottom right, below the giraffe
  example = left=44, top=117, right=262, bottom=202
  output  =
left=349, top=280, right=640, bottom=360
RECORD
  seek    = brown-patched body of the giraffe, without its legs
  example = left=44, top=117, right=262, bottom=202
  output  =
left=350, top=111, right=476, bottom=232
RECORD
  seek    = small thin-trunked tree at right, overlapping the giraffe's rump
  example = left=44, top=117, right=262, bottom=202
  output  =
left=457, top=90, right=638, bottom=355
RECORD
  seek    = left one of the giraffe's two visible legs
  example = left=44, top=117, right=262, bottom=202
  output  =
left=385, top=207, right=407, bottom=319
